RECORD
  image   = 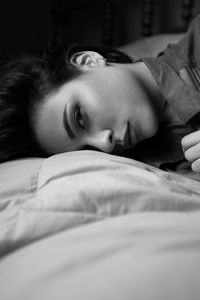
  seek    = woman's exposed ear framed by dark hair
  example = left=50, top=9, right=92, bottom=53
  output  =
left=70, top=51, right=106, bottom=69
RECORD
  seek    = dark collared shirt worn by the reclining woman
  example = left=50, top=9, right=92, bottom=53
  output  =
left=127, top=15, right=200, bottom=177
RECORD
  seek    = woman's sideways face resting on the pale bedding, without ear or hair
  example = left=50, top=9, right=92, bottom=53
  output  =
left=34, top=60, right=157, bottom=154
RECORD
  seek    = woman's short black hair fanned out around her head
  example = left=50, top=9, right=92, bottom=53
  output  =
left=0, top=37, right=132, bottom=162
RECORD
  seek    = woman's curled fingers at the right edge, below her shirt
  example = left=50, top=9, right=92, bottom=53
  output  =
left=181, top=130, right=200, bottom=172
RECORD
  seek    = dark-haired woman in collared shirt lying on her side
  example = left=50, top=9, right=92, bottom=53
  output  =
left=0, top=17, right=200, bottom=172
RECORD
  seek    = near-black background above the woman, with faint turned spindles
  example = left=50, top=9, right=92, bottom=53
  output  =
left=0, top=0, right=200, bottom=58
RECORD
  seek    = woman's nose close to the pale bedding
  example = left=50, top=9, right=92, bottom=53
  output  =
left=89, top=129, right=115, bottom=153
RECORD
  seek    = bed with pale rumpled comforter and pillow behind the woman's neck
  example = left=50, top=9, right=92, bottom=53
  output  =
left=0, top=2, right=200, bottom=300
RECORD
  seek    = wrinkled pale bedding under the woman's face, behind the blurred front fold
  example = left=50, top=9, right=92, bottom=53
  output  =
left=0, top=151, right=200, bottom=257
